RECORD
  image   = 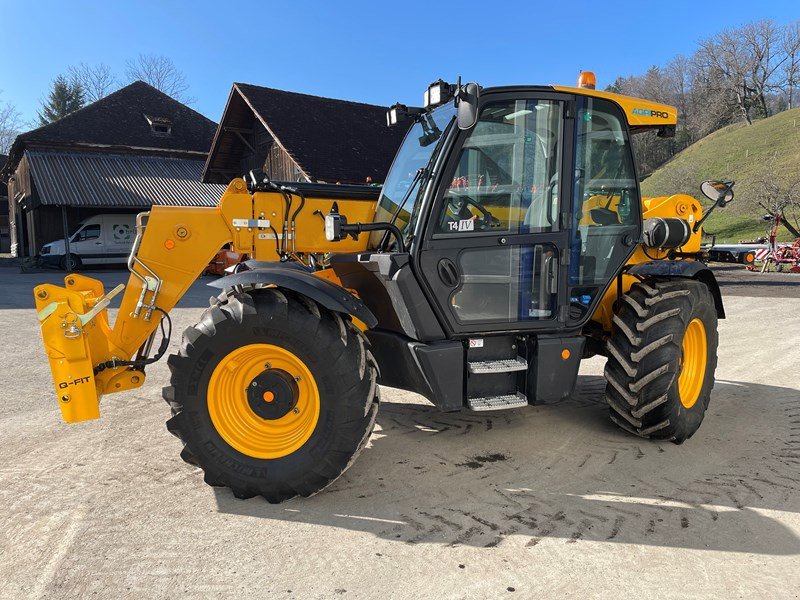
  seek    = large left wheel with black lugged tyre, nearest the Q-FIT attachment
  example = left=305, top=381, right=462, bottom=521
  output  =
left=163, top=289, right=379, bottom=503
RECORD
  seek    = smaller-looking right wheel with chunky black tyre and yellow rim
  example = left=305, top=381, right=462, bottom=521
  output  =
left=605, top=278, right=718, bottom=444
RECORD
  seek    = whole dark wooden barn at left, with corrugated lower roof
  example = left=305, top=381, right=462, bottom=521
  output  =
left=0, top=81, right=225, bottom=257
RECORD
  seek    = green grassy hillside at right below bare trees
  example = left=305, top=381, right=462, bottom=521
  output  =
left=642, top=108, right=800, bottom=242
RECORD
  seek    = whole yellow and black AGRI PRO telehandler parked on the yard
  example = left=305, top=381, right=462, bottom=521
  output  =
left=34, top=73, right=733, bottom=502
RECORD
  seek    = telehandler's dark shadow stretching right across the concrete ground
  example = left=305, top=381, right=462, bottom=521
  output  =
left=208, top=377, right=800, bottom=555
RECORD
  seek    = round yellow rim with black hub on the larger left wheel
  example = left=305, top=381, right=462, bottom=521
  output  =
left=208, top=344, right=320, bottom=458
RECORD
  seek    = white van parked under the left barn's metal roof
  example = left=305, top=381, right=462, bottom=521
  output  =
left=41, top=214, right=136, bottom=270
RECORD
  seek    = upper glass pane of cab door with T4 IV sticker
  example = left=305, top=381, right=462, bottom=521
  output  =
left=435, top=100, right=562, bottom=235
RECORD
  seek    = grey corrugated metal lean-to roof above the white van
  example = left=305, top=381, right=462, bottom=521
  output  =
left=25, top=150, right=225, bottom=208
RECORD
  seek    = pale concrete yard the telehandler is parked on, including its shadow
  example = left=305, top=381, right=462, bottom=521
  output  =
left=0, top=269, right=800, bottom=598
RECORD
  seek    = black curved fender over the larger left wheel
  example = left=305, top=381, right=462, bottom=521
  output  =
left=208, top=261, right=378, bottom=329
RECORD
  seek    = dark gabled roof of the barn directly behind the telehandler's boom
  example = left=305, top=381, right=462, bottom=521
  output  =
left=203, top=83, right=405, bottom=183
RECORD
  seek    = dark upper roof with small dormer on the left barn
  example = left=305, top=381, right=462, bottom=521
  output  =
left=0, top=81, right=216, bottom=179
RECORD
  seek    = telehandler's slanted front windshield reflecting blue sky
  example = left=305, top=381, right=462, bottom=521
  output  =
left=370, top=103, right=456, bottom=247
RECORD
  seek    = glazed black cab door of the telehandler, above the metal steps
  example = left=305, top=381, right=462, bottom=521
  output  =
left=418, top=92, right=574, bottom=335
